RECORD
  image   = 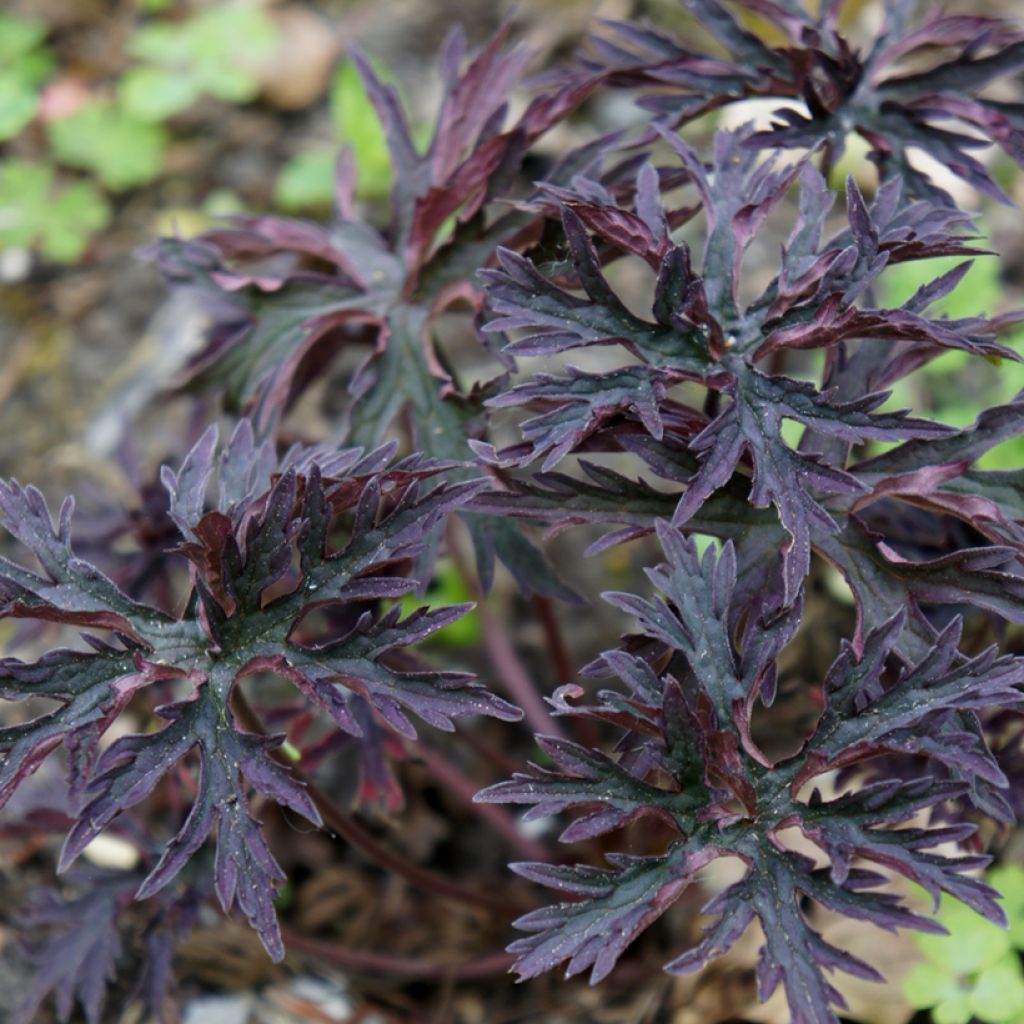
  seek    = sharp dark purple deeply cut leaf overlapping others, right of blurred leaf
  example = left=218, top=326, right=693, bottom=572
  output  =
left=474, top=129, right=1017, bottom=603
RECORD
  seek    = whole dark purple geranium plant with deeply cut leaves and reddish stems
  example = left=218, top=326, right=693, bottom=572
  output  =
left=0, top=0, right=1024, bottom=1024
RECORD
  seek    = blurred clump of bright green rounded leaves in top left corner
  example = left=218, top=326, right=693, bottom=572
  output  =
left=0, top=0, right=280, bottom=262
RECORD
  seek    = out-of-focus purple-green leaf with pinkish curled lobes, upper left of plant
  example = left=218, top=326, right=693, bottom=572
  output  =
left=149, top=24, right=592, bottom=600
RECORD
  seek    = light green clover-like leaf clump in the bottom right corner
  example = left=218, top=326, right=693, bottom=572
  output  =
left=903, top=864, right=1024, bottom=1024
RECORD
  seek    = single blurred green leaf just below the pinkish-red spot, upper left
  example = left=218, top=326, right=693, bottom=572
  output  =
left=47, top=101, right=167, bottom=191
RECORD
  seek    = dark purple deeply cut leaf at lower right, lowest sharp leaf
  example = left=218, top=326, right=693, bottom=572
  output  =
left=477, top=521, right=1024, bottom=1024
